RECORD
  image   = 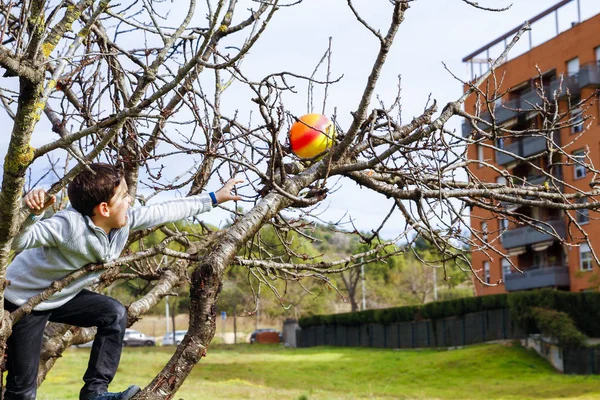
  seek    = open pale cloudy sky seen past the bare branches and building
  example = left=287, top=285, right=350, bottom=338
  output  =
left=0, top=0, right=600, bottom=238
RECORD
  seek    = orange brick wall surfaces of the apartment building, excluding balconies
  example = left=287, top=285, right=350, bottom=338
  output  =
left=465, top=14, right=600, bottom=295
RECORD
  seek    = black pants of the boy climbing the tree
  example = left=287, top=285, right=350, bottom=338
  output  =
left=4, top=290, right=127, bottom=400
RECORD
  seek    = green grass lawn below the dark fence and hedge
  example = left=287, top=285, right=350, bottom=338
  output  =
left=38, top=344, right=600, bottom=400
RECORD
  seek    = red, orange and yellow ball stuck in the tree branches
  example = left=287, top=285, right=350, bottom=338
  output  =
left=290, top=114, right=335, bottom=158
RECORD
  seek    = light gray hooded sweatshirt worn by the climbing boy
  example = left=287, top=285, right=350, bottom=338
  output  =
left=4, top=194, right=212, bottom=311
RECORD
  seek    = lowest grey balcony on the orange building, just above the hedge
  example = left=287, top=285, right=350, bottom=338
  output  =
left=504, top=265, right=570, bottom=292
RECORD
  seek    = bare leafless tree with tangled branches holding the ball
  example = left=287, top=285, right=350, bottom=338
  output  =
left=0, top=0, right=599, bottom=399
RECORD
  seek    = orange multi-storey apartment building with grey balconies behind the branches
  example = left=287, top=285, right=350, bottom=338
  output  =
left=463, top=0, right=600, bottom=295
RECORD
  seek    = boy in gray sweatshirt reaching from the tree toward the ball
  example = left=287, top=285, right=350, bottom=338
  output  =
left=4, top=163, right=243, bottom=400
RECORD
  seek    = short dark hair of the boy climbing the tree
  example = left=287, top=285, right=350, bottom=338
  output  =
left=67, top=163, right=123, bottom=217
